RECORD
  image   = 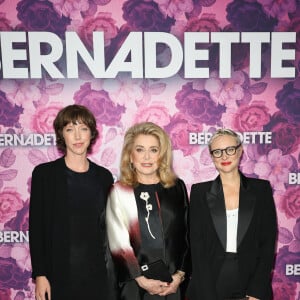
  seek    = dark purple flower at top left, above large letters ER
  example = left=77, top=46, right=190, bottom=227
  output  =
left=16, top=0, right=70, bottom=37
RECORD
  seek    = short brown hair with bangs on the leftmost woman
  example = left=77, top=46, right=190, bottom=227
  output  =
left=53, top=104, right=99, bottom=153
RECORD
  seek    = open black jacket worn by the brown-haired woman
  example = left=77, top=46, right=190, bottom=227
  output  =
left=29, top=158, right=113, bottom=283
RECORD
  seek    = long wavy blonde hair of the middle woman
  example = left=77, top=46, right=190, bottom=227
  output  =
left=120, top=122, right=176, bottom=188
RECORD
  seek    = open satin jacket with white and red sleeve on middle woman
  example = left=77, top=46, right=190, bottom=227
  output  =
left=106, top=179, right=190, bottom=282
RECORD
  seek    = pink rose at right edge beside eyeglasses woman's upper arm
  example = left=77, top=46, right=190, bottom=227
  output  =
left=279, top=186, right=300, bottom=219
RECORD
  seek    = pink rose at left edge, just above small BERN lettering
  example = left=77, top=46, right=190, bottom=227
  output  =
left=0, top=187, right=23, bottom=223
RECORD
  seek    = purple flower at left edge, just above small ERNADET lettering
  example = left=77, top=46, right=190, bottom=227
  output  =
left=0, top=91, right=23, bottom=127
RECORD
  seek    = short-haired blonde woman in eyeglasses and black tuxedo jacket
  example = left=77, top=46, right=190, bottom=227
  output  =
left=188, top=129, right=277, bottom=300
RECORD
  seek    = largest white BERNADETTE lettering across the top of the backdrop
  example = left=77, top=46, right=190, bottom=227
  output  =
left=0, top=31, right=296, bottom=79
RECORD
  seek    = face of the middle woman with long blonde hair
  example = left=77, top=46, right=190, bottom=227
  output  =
left=130, top=134, right=160, bottom=184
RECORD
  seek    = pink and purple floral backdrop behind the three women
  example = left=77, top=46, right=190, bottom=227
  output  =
left=0, top=0, right=300, bottom=300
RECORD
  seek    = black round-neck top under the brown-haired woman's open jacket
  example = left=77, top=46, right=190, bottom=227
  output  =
left=66, top=165, right=107, bottom=299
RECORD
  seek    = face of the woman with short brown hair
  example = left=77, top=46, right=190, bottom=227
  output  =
left=63, top=122, right=91, bottom=156
